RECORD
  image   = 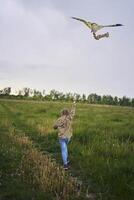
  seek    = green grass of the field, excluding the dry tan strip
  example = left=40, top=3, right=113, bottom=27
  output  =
left=0, top=100, right=134, bottom=200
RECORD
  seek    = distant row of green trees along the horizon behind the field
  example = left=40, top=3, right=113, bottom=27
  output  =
left=0, top=87, right=134, bottom=107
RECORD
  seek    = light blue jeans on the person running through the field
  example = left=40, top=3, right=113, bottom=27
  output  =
left=59, top=138, right=70, bottom=165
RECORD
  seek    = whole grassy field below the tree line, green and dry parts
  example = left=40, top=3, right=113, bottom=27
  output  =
left=0, top=100, right=134, bottom=200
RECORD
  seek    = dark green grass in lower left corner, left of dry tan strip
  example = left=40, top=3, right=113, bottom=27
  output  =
left=0, top=115, right=52, bottom=200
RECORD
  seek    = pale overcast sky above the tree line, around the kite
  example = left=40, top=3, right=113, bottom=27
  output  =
left=0, top=0, right=134, bottom=98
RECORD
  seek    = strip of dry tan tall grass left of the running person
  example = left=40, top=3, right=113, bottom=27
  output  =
left=9, top=129, right=80, bottom=200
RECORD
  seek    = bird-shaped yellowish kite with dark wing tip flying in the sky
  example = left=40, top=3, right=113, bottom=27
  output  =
left=71, top=17, right=123, bottom=40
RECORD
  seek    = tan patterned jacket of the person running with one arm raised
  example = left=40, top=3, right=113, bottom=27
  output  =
left=53, top=107, right=75, bottom=138
